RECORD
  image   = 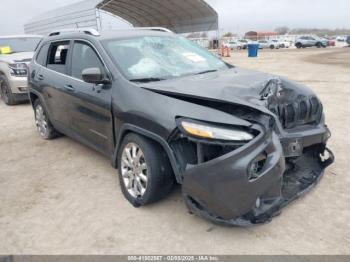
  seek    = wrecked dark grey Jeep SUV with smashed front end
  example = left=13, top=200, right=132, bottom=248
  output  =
left=29, top=29, right=334, bottom=226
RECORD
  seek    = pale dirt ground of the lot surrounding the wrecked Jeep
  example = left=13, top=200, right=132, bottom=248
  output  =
left=0, top=48, right=350, bottom=255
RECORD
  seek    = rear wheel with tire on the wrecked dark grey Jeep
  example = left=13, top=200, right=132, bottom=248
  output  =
left=34, top=99, right=59, bottom=140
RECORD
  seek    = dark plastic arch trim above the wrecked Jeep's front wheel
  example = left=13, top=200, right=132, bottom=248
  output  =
left=112, top=124, right=183, bottom=184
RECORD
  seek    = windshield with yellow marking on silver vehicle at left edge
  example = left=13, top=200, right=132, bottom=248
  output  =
left=0, top=37, right=41, bottom=54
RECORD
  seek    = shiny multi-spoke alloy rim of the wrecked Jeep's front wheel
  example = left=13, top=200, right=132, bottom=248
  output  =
left=120, top=143, right=148, bottom=198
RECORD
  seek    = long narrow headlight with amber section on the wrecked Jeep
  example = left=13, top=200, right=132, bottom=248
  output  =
left=180, top=120, right=254, bottom=141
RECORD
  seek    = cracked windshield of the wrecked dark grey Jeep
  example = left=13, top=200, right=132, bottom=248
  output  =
left=103, top=36, right=230, bottom=80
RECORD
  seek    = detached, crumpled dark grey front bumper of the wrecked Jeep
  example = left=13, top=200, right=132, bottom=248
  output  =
left=182, top=127, right=334, bottom=226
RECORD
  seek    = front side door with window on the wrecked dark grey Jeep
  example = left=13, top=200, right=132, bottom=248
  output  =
left=65, top=41, right=114, bottom=155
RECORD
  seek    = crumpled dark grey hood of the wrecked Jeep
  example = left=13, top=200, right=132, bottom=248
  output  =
left=142, top=68, right=313, bottom=113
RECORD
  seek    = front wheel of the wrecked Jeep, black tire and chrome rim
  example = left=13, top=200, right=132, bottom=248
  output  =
left=117, top=133, right=175, bottom=207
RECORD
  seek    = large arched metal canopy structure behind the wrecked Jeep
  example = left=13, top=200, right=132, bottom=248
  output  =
left=24, top=0, right=218, bottom=35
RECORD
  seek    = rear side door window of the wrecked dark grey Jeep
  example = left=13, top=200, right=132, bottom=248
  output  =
left=47, top=41, right=70, bottom=74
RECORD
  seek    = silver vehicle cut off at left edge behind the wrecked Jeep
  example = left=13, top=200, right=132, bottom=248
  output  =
left=0, top=35, right=42, bottom=105
